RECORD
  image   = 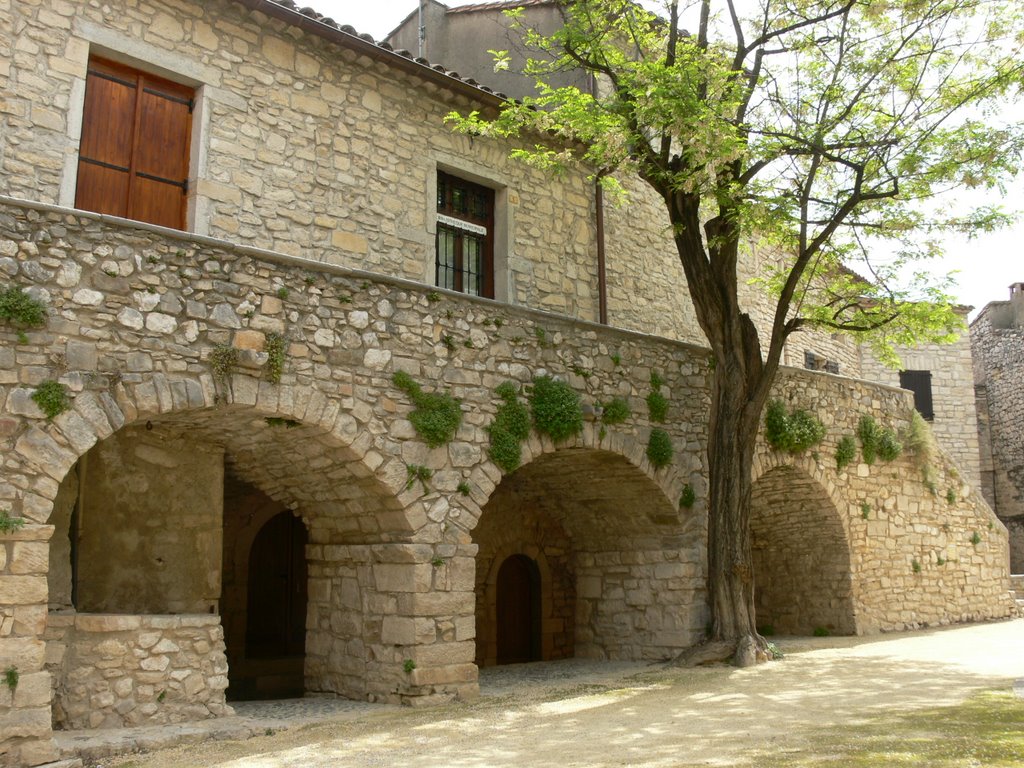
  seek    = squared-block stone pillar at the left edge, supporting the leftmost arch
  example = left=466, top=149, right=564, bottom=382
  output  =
left=0, top=525, right=57, bottom=766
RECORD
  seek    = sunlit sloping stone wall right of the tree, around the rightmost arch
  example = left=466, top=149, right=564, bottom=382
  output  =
left=770, top=370, right=1017, bottom=634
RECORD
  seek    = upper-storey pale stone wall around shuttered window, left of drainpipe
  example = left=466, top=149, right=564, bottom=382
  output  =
left=0, top=0, right=597, bottom=319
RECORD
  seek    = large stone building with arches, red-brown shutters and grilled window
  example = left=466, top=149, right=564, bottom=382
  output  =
left=0, top=0, right=1015, bottom=766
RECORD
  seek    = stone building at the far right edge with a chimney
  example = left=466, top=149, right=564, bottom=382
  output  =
left=971, top=283, right=1024, bottom=573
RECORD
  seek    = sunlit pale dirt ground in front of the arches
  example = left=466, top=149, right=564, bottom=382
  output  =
left=102, top=620, right=1024, bottom=768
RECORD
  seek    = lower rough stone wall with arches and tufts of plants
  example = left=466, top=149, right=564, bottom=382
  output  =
left=0, top=201, right=1013, bottom=762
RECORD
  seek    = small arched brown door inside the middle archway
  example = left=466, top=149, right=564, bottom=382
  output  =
left=496, top=555, right=541, bottom=664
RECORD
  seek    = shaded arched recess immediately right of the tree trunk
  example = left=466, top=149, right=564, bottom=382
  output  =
left=751, top=466, right=856, bottom=635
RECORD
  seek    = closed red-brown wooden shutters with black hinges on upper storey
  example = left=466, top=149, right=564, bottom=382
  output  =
left=75, top=58, right=194, bottom=229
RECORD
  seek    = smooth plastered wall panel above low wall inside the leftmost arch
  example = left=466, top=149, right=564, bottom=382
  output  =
left=72, top=426, right=224, bottom=613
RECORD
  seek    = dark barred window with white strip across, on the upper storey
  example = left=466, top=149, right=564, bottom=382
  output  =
left=434, top=171, right=495, bottom=298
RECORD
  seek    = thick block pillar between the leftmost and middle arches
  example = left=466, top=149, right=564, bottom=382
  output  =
left=306, top=544, right=479, bottom=705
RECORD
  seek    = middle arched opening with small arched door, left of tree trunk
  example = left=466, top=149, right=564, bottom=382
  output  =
left=473, top=447, right=706, bottom=667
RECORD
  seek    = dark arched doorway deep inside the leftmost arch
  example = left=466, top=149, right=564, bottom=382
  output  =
left=246, top=511, right=306, bottom=658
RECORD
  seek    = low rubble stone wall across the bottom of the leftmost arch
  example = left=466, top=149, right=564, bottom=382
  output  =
left=46, top=612, right=231, bottom=730
